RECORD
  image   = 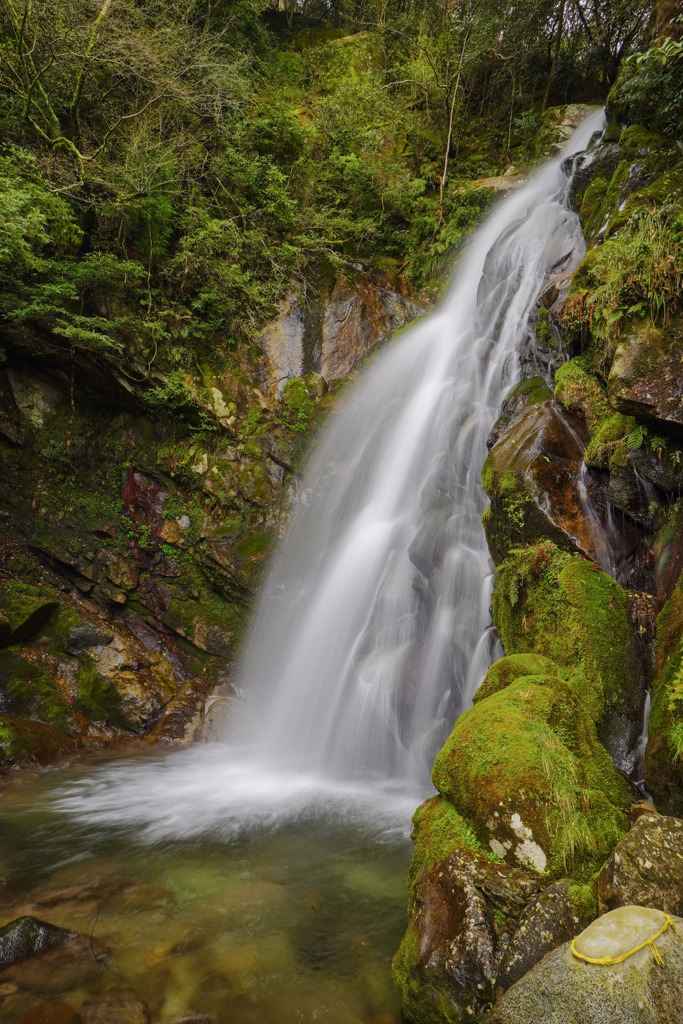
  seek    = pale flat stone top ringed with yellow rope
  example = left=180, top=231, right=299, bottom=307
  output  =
left=571, top=906, right=674, bottom=967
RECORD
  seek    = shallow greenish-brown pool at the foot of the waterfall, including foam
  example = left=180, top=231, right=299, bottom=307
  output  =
left=0, top=749, right=419, bottom=1024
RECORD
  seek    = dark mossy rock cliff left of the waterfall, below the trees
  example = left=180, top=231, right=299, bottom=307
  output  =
left=0, top=266, right=423, bottom=768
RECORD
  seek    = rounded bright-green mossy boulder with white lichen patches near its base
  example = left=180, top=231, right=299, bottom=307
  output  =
left=432, top=675, right=629, bottom=878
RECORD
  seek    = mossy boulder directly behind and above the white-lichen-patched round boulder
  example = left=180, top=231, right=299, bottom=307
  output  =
left=494, top=541, right=645, bottom=771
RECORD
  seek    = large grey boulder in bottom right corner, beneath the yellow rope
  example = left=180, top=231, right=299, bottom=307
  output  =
left=485, top=907, right=683, bottom=1024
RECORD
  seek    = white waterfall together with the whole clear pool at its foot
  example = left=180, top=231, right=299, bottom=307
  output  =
left=0, top=108, right=602, bottom=1024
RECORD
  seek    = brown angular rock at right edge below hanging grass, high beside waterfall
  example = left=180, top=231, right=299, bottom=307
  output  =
left=607, top=316, right=683, bottom=435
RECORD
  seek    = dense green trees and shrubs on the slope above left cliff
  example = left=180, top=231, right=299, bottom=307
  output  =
left=0, top=0, right=663, bottom=391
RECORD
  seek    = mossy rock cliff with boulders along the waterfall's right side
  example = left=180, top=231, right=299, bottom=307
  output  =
left=394, top=110, right=683, bottom=1024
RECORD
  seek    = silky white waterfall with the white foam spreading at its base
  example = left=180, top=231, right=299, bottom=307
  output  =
left=55, top=113, right=603, bottom=840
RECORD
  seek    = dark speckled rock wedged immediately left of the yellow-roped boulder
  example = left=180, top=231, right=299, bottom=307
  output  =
left=496, top=879, right=598, bottom=991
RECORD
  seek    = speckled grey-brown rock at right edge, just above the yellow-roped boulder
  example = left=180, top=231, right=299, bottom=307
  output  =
left=598, top=814, right=683, bottom=915
